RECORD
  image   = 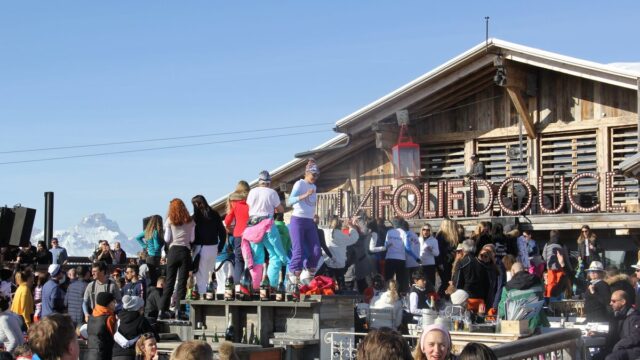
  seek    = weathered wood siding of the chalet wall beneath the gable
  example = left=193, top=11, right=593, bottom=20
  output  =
left=318, top=64, right=639, bottom=211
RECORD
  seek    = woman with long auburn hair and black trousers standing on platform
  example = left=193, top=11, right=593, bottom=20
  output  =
left=159, top=199, right=195, bottom=319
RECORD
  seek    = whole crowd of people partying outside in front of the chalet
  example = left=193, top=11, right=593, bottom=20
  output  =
left=0, top=160, right=640, bottom=360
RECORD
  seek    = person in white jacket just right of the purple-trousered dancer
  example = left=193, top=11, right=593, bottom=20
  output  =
left=323, top=216, right=359, bottom=289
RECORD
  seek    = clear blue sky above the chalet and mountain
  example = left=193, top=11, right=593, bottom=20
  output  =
left=0, top=0, right=640, bottom=240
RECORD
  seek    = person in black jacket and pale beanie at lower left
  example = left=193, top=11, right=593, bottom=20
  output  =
left=112, top=295, right=158, bottom=360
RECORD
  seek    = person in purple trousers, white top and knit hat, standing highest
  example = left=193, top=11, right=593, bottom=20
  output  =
left=287, top=159, right=322, bottom=288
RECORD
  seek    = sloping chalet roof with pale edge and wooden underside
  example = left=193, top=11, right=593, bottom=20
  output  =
left=212, top=39, right=640, bottom=209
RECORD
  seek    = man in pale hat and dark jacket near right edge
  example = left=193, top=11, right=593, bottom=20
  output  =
left=584, top=261, right=611, bottom=322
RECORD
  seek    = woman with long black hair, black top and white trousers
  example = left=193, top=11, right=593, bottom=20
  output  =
left=191, top=195, right=227, bottom=295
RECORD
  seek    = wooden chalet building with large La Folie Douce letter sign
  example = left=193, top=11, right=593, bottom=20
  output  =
left=215, top=39, right=640, bottom=265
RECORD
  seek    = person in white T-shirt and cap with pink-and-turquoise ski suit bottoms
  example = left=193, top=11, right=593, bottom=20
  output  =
left=242, top=170, right=287, bottom=288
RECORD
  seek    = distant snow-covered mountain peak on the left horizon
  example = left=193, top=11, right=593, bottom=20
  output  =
left=31, top=214, right=140, bottom=256
